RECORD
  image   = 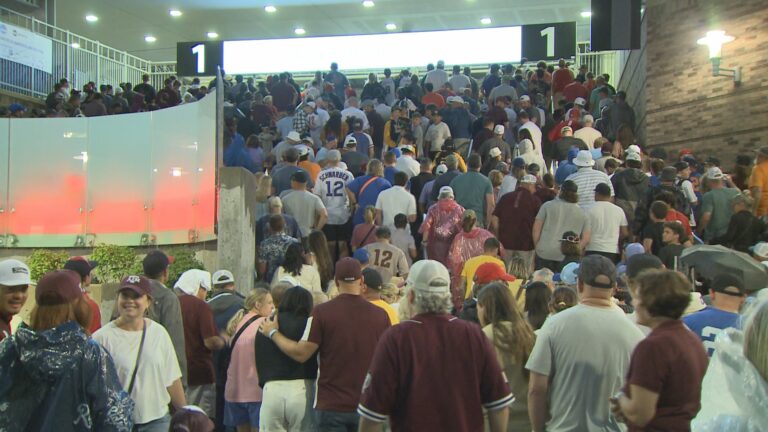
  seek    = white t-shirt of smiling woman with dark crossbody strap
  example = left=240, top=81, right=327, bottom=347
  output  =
left=93, top=318, right=181, bottom=424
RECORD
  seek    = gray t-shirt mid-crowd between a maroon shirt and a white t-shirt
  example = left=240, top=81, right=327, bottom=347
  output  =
left=536, top=198, right=589, bottom=261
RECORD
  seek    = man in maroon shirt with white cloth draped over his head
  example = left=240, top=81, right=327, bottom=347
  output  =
left=174, top=269, right=225, bottom=418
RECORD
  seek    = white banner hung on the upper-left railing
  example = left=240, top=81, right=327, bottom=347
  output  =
left=0, top=23, right=53, bottom=73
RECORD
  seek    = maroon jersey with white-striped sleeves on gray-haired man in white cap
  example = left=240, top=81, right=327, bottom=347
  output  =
left=358, top=314, right=515, bottom=432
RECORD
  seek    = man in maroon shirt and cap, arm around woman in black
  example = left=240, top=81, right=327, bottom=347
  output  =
left=260, top=257, right=390, bottom=432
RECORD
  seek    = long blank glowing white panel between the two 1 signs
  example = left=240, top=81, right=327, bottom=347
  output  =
left=224, top=27, right=522, bottom=74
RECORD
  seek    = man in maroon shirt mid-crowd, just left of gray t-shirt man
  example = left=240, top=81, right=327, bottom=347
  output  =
left=491, top=174, right=541, bottom=270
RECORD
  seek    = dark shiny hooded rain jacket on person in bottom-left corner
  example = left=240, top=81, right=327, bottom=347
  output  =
left=0, top=321, right=133, bottom=432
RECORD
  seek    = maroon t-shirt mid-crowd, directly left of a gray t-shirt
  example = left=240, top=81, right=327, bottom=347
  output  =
left=493, top=188, right=541, bottom=251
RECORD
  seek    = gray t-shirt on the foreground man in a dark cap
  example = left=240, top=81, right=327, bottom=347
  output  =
left=525, top=305, right=644, bottom=432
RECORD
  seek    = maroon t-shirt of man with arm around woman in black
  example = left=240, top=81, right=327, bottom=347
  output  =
left=303, top=294, right=390, bottom=412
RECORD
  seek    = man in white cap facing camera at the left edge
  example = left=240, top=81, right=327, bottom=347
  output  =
left=0, top=260, right=32, bottom=340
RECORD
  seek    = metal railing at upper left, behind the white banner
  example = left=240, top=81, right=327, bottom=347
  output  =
left=0, top=7, right=176, bottom=98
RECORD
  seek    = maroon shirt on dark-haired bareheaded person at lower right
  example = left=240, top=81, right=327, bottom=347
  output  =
left=624, top=320, right=708, bottom=432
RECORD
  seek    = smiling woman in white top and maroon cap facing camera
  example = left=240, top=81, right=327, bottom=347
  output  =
left=93, top=276, right=187, bottom=432
